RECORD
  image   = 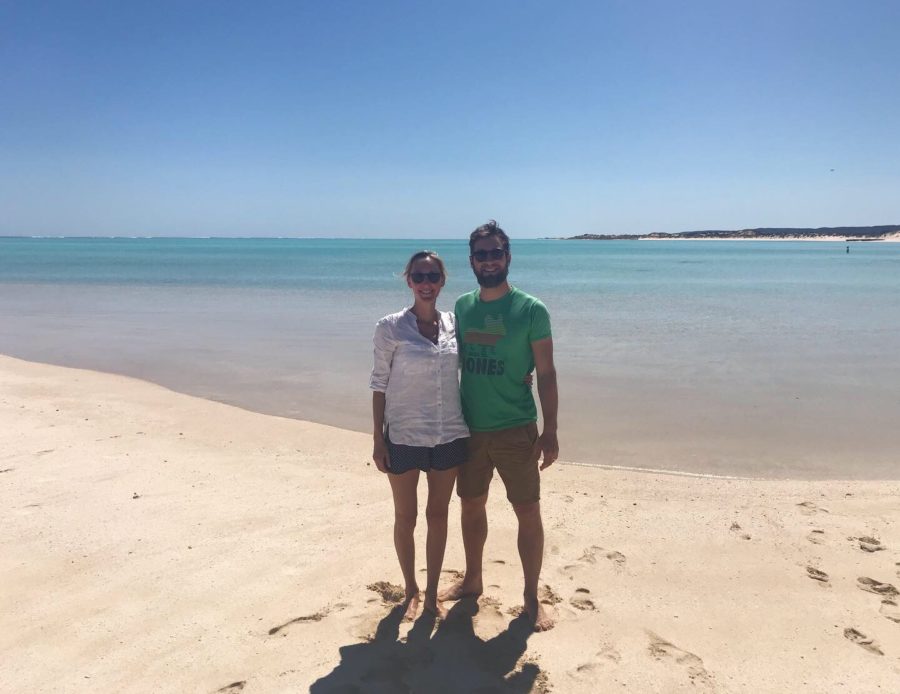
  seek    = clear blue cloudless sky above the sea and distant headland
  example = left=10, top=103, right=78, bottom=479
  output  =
left=0, top=0, right=900, bottom=237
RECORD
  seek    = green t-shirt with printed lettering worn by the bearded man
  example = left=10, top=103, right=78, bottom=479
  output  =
left=456, top=287, right=550, bottom=431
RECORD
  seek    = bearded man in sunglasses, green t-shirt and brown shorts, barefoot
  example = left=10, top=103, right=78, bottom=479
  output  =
left=441, top=220, right=559, bottom=631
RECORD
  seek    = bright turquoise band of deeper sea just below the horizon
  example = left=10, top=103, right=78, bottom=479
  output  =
left=0, top=238, right=900, bottom=294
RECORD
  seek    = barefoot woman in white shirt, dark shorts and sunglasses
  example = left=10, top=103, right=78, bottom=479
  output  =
left=369, top=251, right=469, bottom=620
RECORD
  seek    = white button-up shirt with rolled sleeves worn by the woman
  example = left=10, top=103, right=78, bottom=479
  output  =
left=369, top=309, right=469, bottom=448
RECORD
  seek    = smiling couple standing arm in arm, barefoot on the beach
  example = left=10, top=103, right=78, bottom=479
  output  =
left=369, top=220, right=559, bottom=631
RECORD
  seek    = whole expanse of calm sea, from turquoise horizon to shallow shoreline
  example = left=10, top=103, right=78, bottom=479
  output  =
left=0, top=238, right=900, bottom=477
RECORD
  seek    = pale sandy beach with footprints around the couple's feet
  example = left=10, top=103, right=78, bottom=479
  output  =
left=0, top=357, right=900, bottom=694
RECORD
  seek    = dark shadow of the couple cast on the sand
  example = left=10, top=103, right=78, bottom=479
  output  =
left=310, top=599, right=547, bottom=694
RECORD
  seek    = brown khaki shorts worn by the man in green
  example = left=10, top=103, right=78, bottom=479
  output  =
left=456, top=422, right=541, bottom=504
